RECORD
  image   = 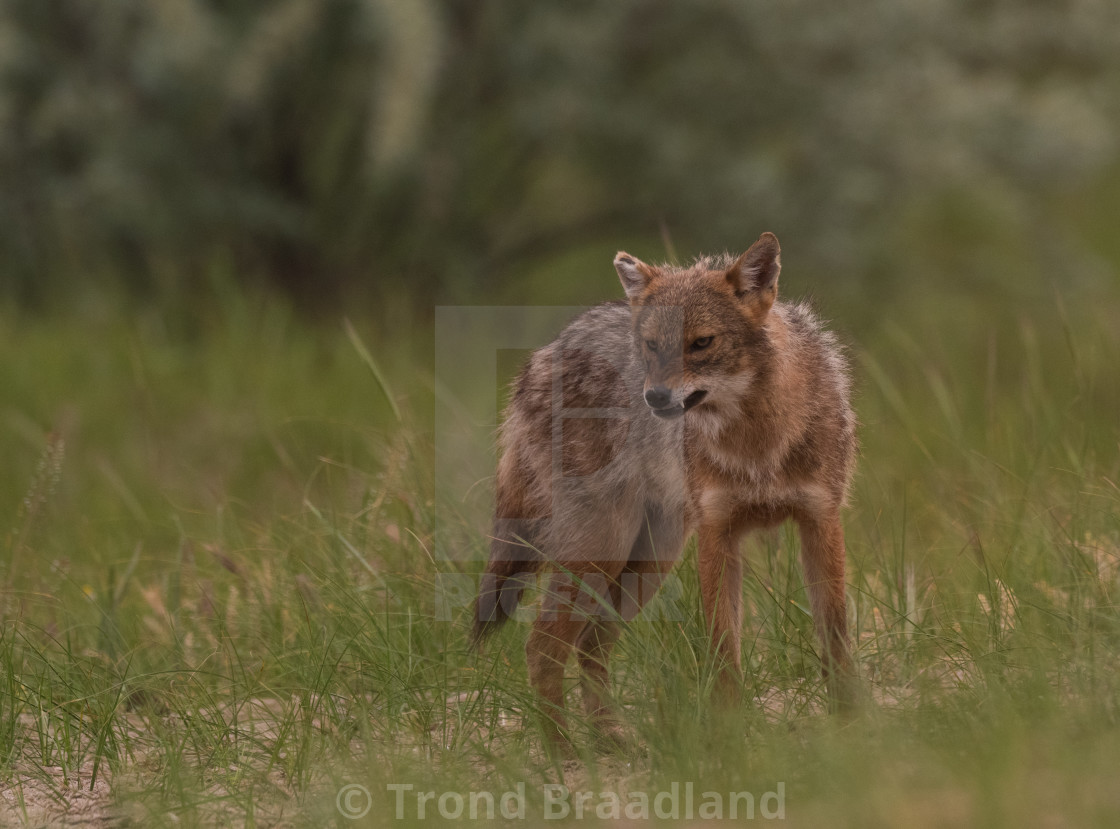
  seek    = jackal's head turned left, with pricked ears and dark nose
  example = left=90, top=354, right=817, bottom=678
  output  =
left=615, top=233, right=782, bottom=418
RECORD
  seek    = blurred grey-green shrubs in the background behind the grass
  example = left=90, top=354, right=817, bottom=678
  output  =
left=0, top=0, right=1120, bottom=302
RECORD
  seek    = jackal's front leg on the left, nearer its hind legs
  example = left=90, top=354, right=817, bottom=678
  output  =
left=699, top=521, right=743, bottom=704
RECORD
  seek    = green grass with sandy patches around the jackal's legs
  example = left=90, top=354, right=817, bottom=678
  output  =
left=0, top=280, right=1120, bottom=827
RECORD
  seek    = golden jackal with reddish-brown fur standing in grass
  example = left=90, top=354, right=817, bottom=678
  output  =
left=474, top=233, right=856, bottom=738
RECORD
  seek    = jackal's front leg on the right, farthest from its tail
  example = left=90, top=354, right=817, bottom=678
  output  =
left=796, top=510, right=857, bottom=710
